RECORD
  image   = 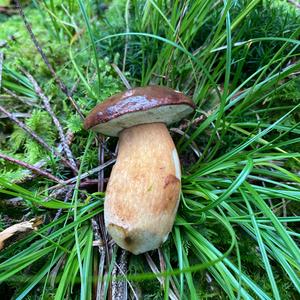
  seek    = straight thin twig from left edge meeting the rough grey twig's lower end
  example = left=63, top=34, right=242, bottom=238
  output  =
left=0, top=105, right=76, bottom=172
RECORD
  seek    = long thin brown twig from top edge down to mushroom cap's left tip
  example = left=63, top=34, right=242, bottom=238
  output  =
left=16, top=0, right=84, bottom=119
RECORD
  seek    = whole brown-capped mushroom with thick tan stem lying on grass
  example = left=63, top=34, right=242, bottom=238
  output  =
left=84, top=86, right=194, bottom=254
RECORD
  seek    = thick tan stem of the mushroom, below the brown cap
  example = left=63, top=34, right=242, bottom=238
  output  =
left=104, top=123, right=181, bottom=254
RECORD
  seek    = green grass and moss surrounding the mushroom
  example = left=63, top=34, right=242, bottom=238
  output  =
left=0, top=0, right=300, bottom=299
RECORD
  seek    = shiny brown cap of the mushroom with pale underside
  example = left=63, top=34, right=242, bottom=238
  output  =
left=84, top=86, right=195, bottom=136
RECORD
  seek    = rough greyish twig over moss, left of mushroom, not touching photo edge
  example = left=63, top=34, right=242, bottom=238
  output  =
left=22, top=69, right=78, bottom=174
